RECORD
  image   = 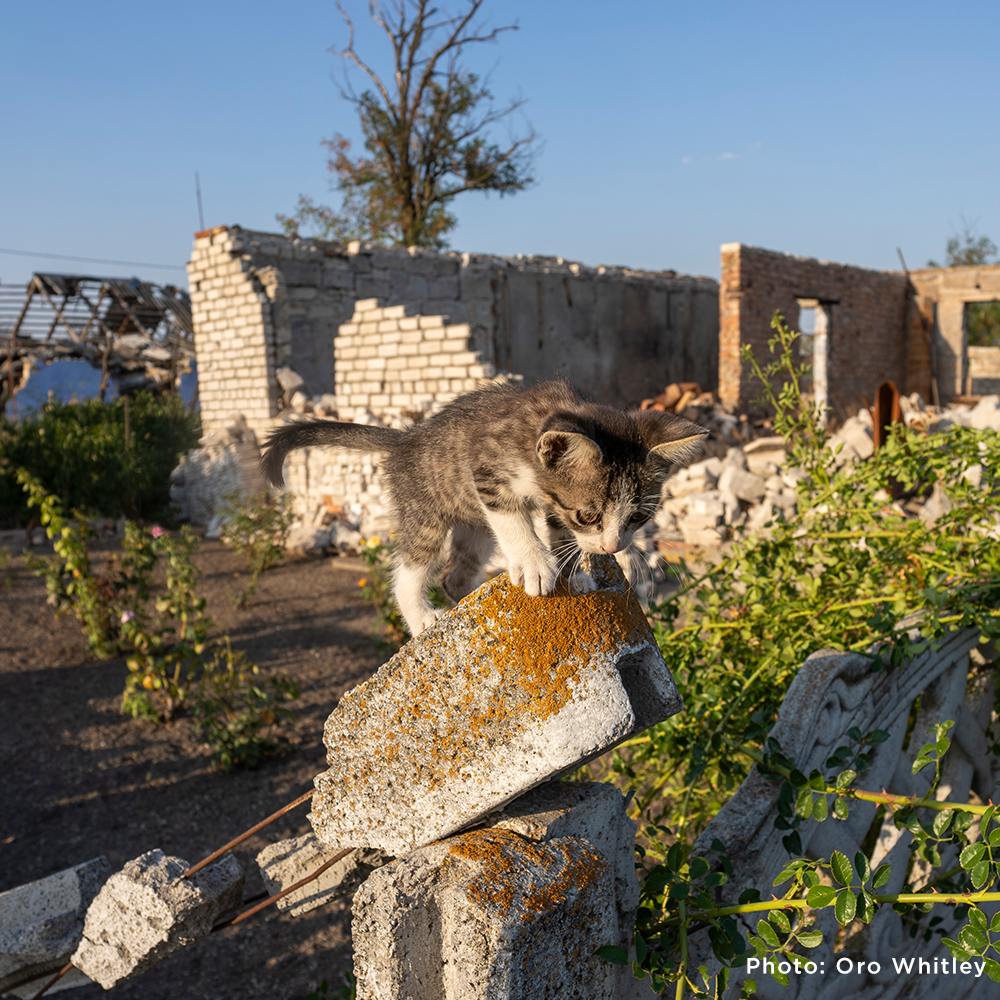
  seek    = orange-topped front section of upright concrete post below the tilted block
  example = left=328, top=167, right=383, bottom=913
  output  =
left=352, top=829, right=618, bottom=1000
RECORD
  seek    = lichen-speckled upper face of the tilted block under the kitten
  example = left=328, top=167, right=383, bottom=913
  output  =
left=314, top=566, right=652, bottom=824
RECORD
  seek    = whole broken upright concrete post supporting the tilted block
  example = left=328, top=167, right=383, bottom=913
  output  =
left=352, top=781, right=640, bottom=1000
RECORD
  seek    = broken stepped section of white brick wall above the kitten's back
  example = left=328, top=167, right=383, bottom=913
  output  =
left=334, top=299, right=496, bottom=420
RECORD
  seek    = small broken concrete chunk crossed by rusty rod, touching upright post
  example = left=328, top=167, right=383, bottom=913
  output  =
left=257, top=833, right=390, bottom=917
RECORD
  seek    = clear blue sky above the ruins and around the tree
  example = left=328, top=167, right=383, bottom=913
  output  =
left=0, top=0, right=1000, bottom=283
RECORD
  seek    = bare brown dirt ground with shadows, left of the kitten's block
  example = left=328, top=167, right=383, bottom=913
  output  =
left=0, top=541, right=384, bottom=1000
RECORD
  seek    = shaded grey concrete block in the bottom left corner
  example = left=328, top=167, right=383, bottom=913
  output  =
left=0, top=857, right=111, bottom=997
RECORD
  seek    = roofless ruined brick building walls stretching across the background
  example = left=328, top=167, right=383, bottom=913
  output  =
left=188, top=226, right=1000, bottom=431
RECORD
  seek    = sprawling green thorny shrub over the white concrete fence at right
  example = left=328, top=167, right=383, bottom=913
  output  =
left=600, top=315, right=1000, bottom=1000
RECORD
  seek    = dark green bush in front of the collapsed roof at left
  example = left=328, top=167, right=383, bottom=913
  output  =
left=0, top=392, right=201, bottom=525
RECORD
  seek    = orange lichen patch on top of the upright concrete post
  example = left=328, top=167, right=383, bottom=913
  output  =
left=444, top=829, right=608, bottom=923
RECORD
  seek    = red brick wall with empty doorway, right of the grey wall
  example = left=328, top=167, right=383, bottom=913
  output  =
left=719, top=243, right=907, bottom=420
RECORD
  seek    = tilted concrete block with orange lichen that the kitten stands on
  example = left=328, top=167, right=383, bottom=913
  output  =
left=309, top=557, right=682, bottom=857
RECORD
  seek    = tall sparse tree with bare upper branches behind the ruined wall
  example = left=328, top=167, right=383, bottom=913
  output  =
left=278, top=0, right=536, bottom=247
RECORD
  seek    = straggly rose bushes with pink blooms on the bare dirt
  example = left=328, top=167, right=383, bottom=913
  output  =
left=18, top=469, right=300, bottom=771
